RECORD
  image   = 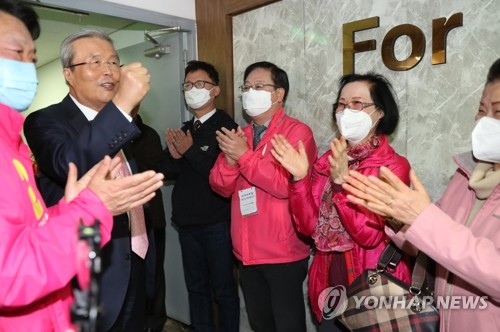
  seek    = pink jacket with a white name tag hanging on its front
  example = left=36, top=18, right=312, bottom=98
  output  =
left=210, top=109, right=317, bottom=265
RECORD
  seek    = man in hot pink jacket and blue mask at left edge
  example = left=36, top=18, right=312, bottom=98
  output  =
left=0, top=0, right=163, bottom=332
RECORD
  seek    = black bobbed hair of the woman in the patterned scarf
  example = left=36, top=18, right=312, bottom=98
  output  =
left=333, top=72, right=399, bottom=135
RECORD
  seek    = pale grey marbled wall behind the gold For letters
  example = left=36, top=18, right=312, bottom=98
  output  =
left=233, top=0, right=500, bottom=199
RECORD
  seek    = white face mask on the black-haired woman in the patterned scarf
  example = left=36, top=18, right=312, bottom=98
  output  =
left=335, top=108, right=376, bottom=143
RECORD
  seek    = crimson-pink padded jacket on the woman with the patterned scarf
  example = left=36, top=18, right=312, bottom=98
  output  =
left=290, top=136, right=411, bottom=321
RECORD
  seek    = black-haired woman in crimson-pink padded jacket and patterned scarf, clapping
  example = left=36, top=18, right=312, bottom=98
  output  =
left=271, top=73, right=410, bottom=331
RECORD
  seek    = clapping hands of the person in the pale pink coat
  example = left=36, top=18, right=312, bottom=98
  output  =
left=342, top=167, right=431, bottom=225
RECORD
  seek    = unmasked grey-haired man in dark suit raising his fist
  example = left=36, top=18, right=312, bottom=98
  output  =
left=24, top=30, right=155, bottom=332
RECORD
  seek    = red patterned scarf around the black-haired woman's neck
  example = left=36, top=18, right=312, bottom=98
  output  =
left=312, top=135, right=381, bottom=252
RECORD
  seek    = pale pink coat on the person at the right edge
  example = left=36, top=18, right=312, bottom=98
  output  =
left=397, top=152, right=500, bottom=332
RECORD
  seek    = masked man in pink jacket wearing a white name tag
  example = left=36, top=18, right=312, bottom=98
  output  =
left=210, top=62, right=317, bottom=332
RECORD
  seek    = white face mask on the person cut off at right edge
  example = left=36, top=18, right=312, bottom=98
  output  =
left=472, top=116, right=500, bottom=163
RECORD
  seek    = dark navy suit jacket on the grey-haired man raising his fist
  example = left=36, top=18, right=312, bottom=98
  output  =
left=24, top=95, right=154, bottom=330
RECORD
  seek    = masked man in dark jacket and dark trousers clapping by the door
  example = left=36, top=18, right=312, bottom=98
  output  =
left=159, top=61, right=240, bottom=332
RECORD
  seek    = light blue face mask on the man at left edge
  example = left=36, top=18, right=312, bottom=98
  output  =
left=0, top=58, right=38, bottom=112
